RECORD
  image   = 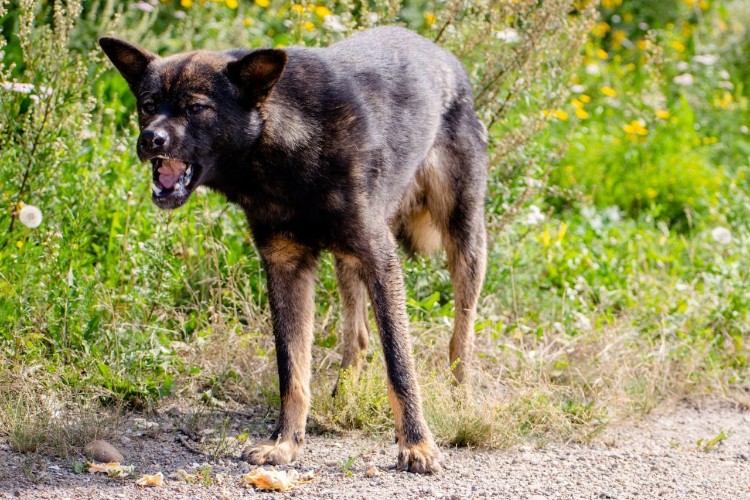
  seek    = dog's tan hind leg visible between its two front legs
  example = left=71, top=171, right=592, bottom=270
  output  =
left=334, top=257, right=370, bottom=393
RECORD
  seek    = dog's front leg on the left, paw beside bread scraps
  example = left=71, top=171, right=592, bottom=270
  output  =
left=242, top=238, right=316, bottom=465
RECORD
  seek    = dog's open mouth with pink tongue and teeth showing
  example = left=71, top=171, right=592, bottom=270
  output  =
left=151, top=156, right=200, bottom=208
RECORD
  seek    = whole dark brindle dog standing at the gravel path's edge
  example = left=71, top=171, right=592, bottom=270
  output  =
left=100, top=28, right=487, bottom=472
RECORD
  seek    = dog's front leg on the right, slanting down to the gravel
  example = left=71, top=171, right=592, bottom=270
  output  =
left=360, top=230, right=440, bottom=473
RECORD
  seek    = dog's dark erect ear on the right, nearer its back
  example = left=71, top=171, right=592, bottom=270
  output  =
left=227, top=49, right=286, bottom=104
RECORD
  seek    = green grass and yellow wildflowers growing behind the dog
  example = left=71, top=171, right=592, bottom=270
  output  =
left=0, top=0, right=750, bottom=458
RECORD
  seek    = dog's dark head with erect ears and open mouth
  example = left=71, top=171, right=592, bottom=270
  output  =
left=99, top=37, right=286, bottom=208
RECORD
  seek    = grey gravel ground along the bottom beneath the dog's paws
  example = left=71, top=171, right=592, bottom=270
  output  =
left=0, top=401, right=750, bottom=500
